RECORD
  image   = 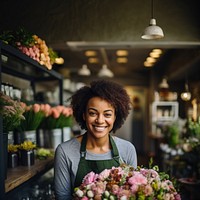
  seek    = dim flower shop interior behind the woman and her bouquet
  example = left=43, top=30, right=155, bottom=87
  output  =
left=0, top=0, right=200, bottom=200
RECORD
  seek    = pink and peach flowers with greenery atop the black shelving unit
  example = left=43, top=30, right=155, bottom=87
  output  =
left=0, top=28, right=61, bottom=70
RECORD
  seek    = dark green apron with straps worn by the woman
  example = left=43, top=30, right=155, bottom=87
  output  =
left=74, top=133, right=120, bottom=187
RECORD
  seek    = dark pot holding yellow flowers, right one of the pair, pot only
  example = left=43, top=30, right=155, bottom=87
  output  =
left=20, top=150, right=35, bottom=166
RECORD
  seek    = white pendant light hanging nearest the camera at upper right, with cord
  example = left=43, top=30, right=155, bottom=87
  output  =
left=141, top=0, right=164, bottom=40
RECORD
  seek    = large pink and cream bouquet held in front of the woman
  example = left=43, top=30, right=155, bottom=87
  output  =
left=73, top=164, right=181, bottom=200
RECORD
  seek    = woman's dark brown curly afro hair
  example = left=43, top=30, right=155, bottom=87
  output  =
left=70, top=80, right=131, bottom=133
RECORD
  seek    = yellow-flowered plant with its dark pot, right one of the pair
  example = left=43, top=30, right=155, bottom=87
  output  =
left=19, top=140, right=36, bottom=166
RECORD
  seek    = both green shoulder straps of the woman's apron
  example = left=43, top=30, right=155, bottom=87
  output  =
left=80, top=133, right=119, bottom=159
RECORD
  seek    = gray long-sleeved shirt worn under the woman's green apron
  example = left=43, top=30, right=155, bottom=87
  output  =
left=54, top=136, right=137, bottom=200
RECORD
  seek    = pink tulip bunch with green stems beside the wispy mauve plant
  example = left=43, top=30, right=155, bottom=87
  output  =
left=17, top=103, right=51, bottom=132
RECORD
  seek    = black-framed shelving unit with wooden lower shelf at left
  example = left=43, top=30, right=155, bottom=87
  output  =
left=0, top=41, right=63, bottom=199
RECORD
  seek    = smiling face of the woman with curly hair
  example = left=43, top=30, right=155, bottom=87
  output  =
left=83, top=97, right=116, bottom=138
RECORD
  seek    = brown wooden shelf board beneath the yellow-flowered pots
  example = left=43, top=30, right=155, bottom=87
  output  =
left=5, top=157, right=53, bottom=192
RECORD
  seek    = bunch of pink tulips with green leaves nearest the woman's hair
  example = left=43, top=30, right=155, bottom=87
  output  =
left=41, top=105, right=73, bottom=130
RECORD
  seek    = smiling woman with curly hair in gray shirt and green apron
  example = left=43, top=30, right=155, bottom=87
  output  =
left=54, top=80, right=137, bottom=200
